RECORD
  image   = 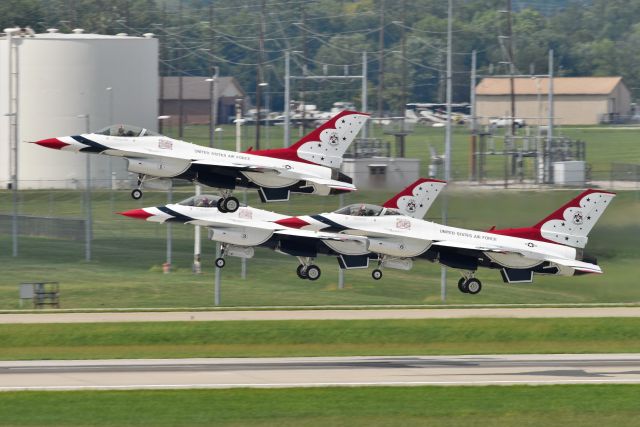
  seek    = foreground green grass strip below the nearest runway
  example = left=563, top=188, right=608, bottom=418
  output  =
left=0, top=385, right=640, bottom=427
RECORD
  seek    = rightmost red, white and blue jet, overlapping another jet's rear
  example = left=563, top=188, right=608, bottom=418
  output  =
left=276, top=191, right=615, bottom=294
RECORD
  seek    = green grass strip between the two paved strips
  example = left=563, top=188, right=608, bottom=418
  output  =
left=0, top=318, right=640, bottom=360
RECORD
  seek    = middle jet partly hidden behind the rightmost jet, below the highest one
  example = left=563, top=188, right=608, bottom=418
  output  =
left=121, top=179, right=445, bottom=280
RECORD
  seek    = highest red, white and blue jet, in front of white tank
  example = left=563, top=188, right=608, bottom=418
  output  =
left=35, top=111, right=368, bottom=212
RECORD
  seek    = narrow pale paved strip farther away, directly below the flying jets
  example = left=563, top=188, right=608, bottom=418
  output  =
left=0, top=307, right=640, bottom=324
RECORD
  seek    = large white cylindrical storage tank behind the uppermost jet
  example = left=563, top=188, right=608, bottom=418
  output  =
left=0, top=30, right=158, bottom=189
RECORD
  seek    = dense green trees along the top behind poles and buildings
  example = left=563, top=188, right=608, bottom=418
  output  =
left=0, top=0, right=640, bottom=114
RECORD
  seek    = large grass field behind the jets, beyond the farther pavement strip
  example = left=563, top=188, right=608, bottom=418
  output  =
left=0, top=190, right=640, bottom=309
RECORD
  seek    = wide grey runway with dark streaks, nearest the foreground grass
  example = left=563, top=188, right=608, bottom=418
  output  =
left=0, top=354, right=640, bottom=391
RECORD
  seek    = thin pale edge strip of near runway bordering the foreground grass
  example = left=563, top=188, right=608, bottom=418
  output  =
left=0, top=378, right=640, bottom=392
